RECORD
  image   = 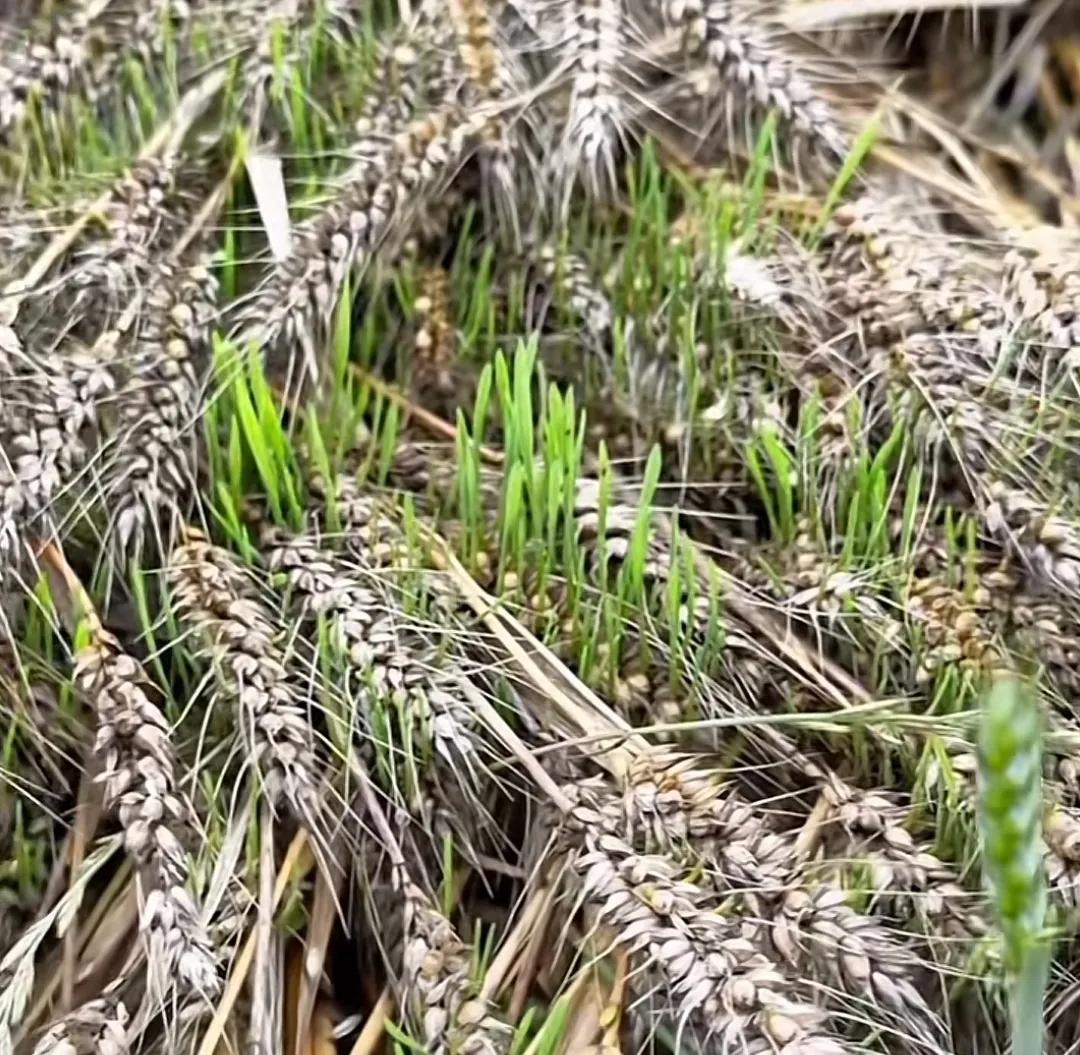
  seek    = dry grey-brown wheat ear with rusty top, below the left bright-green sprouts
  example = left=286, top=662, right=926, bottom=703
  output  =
left=167, top=529, right=320, bottom=833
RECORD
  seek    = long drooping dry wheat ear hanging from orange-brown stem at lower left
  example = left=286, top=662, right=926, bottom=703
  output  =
left=75, top=627, right=218, bottom=998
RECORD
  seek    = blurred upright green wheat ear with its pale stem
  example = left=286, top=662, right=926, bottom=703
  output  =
left=978, top=680, right=1050, bottom=1055
